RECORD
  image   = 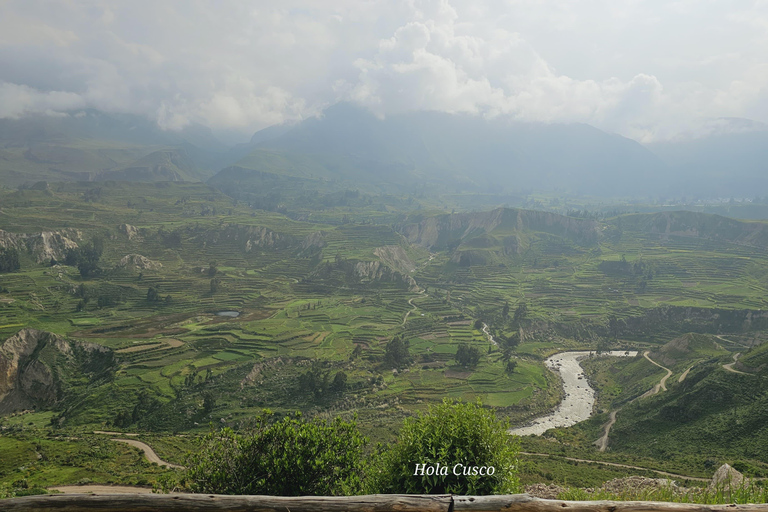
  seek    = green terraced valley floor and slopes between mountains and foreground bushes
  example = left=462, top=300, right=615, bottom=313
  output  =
left=0, top=180, right=768, bottom=487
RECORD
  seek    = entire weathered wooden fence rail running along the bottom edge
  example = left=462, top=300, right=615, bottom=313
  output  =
left=0, top=494, right=768, bottom=512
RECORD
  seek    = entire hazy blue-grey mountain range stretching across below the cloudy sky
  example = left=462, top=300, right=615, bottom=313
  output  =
left=0, top=103, right=768, bottom=199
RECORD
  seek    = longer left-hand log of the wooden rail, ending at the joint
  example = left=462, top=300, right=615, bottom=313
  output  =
left=0, top=494, right=451, bottom=512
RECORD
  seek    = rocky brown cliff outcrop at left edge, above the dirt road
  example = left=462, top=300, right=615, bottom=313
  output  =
left=0, top=329, right=114, bottom=414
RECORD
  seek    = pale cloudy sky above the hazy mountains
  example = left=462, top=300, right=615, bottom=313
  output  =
left=0, top=0, right=768, bottom=142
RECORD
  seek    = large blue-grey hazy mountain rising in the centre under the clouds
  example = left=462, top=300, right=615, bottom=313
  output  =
left=228, top=104, right=665, bottom=195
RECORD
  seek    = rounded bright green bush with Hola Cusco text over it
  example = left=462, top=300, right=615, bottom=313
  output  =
left=368, top=399, right=520, bottom=495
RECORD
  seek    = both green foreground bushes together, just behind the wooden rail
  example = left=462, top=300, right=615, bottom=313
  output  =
left=180, top=399, right=520, bottom=496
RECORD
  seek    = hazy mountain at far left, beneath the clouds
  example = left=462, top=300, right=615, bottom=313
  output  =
left=0, top=110, right=226, bottom=186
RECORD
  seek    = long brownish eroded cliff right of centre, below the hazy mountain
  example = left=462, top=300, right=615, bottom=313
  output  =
left=397, top=208, right=600, bottom=252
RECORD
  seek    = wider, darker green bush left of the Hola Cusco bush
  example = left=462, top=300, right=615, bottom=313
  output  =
left=187, top=413, right=367, bottom=496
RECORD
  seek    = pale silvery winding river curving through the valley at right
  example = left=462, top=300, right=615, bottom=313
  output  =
left=509, top=350, right=637, bottom=436
